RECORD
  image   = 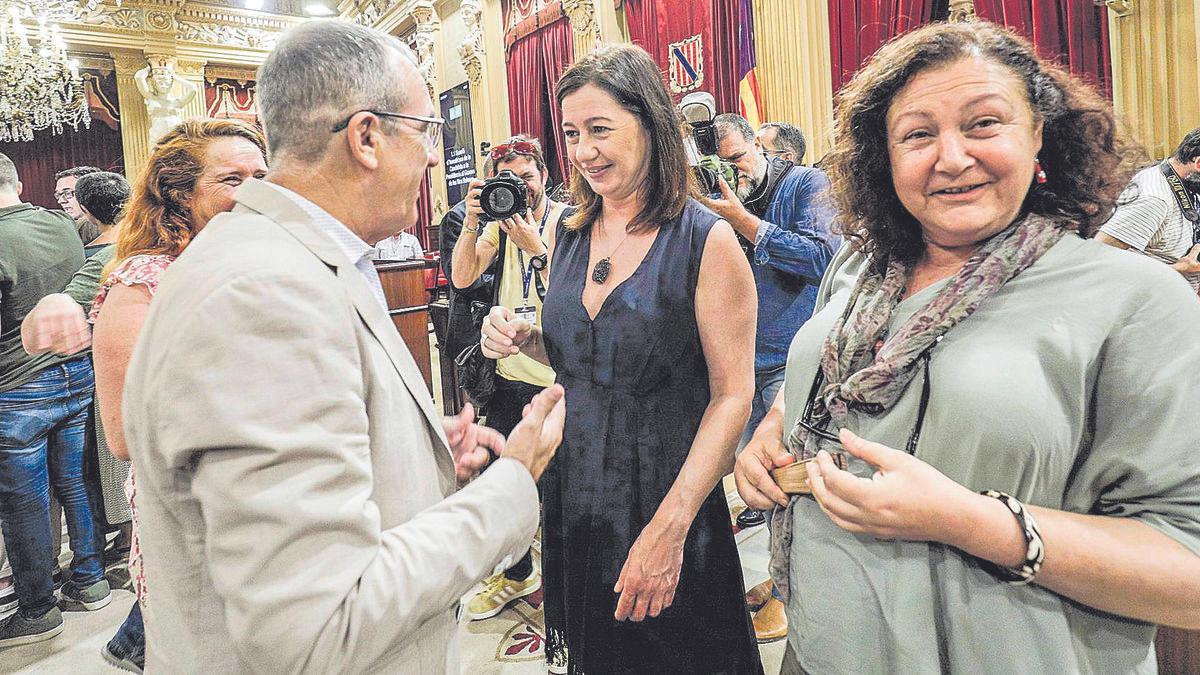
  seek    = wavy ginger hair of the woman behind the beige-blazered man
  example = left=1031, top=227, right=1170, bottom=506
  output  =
left=103, top=120, right=266, bottom=276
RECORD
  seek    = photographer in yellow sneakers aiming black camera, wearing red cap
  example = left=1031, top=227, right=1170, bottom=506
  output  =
left=450, top=136, right=569, bottom=620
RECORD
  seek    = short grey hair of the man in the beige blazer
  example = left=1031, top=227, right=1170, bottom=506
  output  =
left=258, top=19, right=416, bottom=161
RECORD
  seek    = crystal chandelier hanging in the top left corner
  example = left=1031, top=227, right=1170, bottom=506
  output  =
left=0, top=0, right=91, bottom=143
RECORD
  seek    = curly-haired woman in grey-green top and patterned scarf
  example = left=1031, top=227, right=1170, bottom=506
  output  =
left=736, top=23, right=1200, bottom=674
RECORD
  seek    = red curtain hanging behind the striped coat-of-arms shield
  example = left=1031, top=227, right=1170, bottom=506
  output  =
left=624, top=0, right=742, bottom=113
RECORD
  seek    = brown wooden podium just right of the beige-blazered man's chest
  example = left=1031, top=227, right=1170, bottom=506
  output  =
left=374, top=259, right=438, bottom=396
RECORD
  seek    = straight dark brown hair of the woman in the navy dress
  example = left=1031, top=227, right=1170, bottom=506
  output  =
left=554, top=44, right=694, bottom=232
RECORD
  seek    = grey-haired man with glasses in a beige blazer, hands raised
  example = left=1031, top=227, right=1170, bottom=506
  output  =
left=125, top=22, right=563, bottom=675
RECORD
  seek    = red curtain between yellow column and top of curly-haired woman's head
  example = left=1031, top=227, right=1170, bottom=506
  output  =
left=829, top=0, right=936, bottom=92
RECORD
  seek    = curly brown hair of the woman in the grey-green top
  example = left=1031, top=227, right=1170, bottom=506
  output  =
left=822, top=22, right=1145, bottom=273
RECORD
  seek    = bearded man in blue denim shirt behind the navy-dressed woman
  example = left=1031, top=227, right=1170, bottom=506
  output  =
left=704, top=114, right=841, bottom=643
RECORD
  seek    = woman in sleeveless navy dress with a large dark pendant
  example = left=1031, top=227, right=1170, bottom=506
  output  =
left=482, top=46, right=762, bottom=674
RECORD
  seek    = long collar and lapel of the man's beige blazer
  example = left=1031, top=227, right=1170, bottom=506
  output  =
left=234, top=179, right=454, bottom=461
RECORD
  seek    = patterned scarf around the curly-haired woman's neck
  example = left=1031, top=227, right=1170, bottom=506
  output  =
left=770, top=215, right=1067, bottom=601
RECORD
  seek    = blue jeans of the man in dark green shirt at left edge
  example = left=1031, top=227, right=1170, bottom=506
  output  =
left=0, top=357, right=104, bottom=617
